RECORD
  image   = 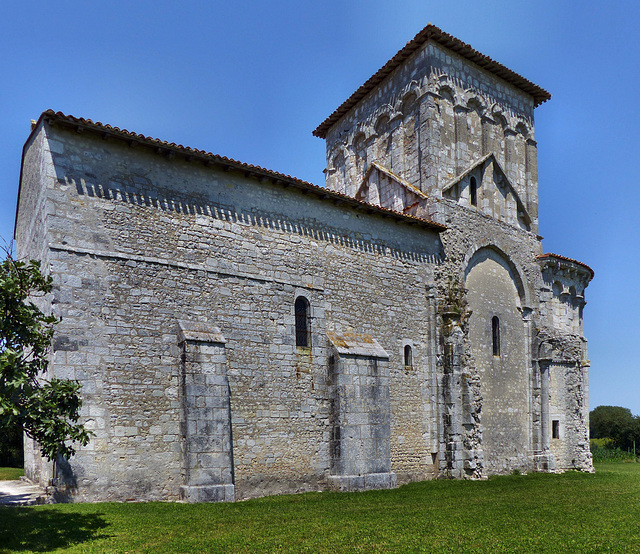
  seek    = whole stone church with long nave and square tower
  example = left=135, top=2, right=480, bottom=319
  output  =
left=15, top=25, right=593, bottom=502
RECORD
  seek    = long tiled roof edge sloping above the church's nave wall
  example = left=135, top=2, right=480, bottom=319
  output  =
left=28, top=110, right=447, bottom=232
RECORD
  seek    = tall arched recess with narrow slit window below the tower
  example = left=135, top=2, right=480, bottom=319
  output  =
left=465, top=247, right=531, bottom=474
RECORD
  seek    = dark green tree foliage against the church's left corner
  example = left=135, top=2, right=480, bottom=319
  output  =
left=0, top=254, right=89, bottom=460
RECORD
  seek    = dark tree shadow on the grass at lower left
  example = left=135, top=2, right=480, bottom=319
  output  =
left=0, top=506, right=109, bottom=554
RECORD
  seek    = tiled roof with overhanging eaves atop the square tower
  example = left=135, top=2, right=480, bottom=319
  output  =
left=313, top=23, right=551, bottom=138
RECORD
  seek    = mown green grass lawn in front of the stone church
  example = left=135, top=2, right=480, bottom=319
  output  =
left=0, top=463, right=640, bottom=553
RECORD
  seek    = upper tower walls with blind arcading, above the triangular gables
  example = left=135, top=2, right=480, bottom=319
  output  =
left=326, top=43, right=538, bottom=230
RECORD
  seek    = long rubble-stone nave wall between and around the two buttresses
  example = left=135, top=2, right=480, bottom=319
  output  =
left=18, top=124, right=441, bottom=500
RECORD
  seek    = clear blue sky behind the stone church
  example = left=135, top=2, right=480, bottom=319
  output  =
left=0, top=0, right=640, bottom=414
